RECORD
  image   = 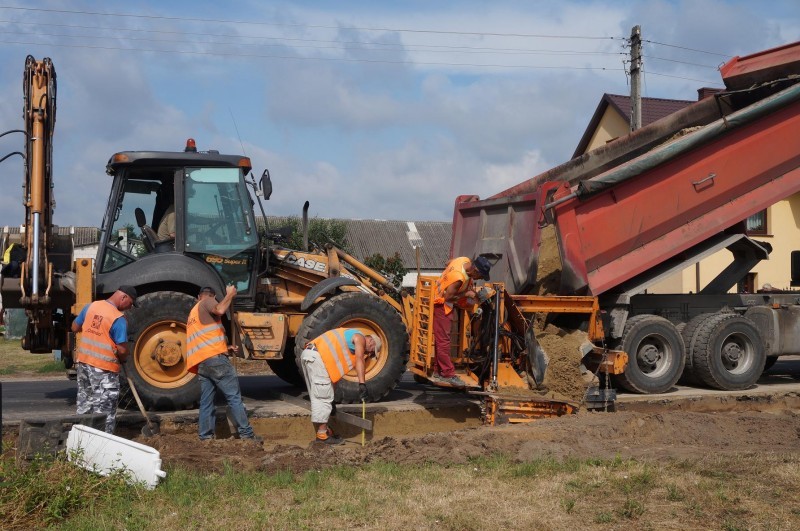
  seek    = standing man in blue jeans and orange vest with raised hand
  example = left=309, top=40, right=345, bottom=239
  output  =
left=186, top=286, right=263, bottom=442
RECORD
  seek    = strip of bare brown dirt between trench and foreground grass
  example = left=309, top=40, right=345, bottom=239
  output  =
left=137, top=399, right=800, bottom=473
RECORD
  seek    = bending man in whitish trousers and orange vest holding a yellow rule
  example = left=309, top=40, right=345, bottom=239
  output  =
left=300, top=328, right=381, bottom=445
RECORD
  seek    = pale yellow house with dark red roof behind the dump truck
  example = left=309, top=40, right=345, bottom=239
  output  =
left=573, top=88, right=800, bottom=293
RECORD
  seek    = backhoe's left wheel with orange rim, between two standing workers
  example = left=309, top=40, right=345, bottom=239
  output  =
left=125, top=291, right=200, bottom=410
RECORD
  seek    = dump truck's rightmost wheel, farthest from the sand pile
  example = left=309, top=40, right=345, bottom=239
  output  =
left=692, top=313, right=766, bottom=391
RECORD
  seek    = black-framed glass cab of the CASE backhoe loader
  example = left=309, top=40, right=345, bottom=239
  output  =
left=96, top=145, right=258, bottom=296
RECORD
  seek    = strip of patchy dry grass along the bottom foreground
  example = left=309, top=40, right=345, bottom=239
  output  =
left=0, top=444, right=800, bottom=531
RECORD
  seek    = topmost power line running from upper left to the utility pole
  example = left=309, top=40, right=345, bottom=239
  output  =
left=0, top=6, right=623, bottom=40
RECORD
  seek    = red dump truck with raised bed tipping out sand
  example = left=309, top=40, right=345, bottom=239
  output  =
left=451, top=43, right=800, bottom=393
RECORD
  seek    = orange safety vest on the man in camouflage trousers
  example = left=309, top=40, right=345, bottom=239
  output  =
left=75, top=301, right=122, bottom=372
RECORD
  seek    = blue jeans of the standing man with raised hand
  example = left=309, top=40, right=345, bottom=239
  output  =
left=197, top=355, right=255, bottom=440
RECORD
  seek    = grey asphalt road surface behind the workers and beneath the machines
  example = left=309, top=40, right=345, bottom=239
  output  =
left=0, top=356, right=800, bottom=425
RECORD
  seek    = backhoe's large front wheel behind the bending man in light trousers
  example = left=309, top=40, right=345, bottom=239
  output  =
left=295, top=292, right=409, bottom=404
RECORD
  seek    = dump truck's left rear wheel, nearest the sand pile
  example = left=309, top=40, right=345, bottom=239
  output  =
left=615, top=315, right=686, bottom=393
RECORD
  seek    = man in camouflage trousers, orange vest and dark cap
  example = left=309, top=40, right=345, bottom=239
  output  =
left=71, top=286, right=137, bottom=433
